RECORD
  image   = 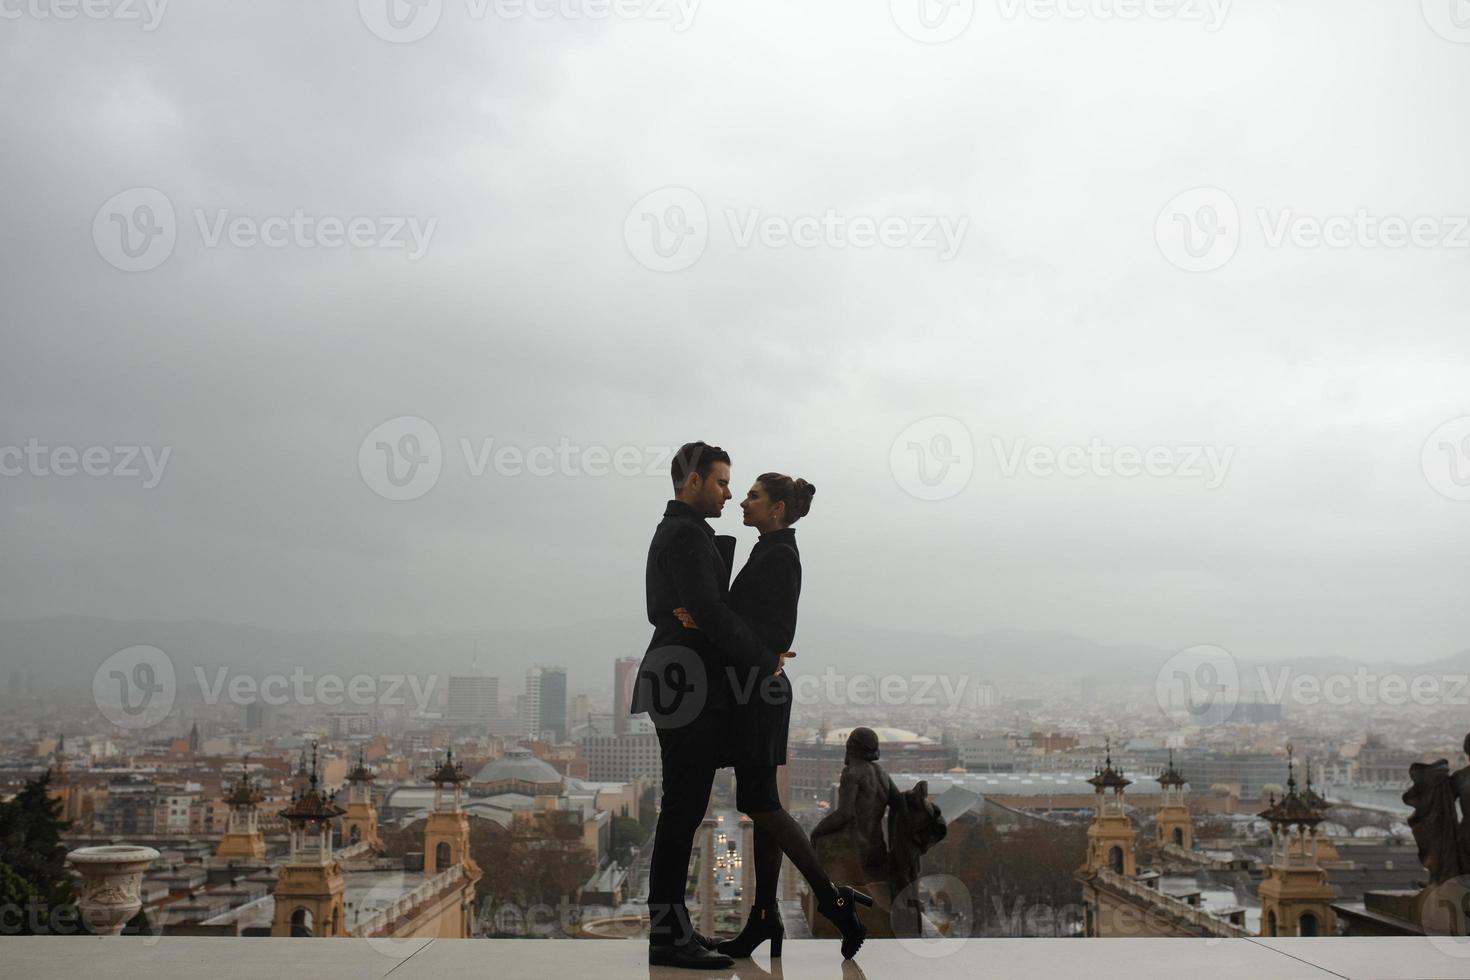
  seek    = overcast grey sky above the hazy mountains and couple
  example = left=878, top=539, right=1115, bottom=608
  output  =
left=0, top=0, right=1470, bottom=658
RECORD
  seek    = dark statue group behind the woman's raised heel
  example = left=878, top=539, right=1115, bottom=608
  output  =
left=811, top=727, right=945, bottom=936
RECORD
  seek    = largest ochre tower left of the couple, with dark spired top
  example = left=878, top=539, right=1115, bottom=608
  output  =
left=270, top=748, right=347, bottom=937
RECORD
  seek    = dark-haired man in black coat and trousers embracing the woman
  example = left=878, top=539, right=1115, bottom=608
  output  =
left=631, top=442, right=763, bottom=970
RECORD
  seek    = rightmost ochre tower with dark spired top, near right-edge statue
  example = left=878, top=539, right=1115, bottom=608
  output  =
left=1260, top=745, right=1338, bottom=936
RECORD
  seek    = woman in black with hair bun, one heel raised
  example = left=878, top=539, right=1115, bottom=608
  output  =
left=675, top=473, right=873, bottom=959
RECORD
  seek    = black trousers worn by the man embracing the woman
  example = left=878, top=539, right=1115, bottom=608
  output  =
left=648, top=704, right=732, bottom=945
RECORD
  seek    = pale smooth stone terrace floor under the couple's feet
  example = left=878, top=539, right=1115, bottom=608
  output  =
left=0, top=936, right=1470, bottom=980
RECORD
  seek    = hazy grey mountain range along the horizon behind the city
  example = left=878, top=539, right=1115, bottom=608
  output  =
left=0, top=617, right=1470, bottom=699
